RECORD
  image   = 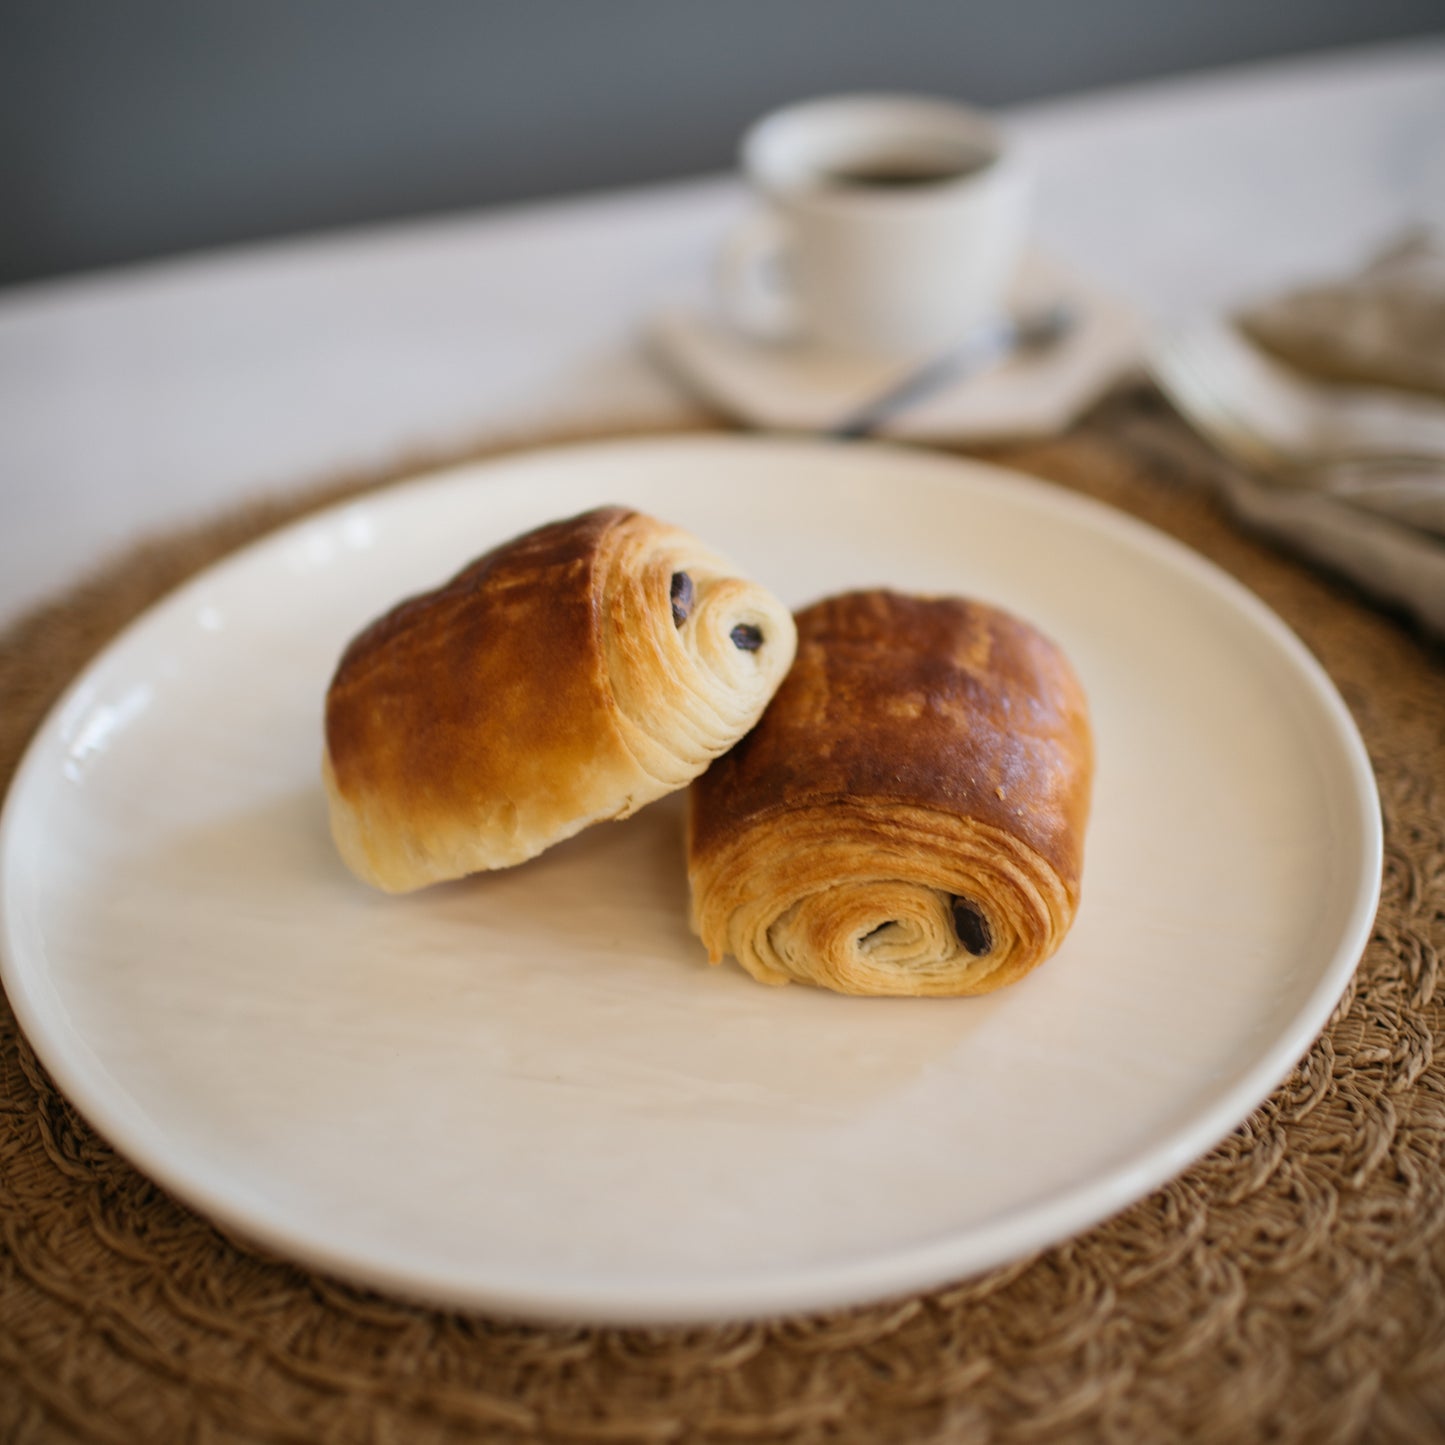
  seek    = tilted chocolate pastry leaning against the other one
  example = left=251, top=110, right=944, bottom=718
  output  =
left=322, top=507, right=796, bottom=893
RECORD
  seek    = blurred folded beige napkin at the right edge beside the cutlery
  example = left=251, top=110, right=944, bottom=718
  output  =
left=1224, top=231, right=1445, bottom=639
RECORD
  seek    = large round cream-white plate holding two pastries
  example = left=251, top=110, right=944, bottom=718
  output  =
left=0, top=439, right=1380, bottom=1322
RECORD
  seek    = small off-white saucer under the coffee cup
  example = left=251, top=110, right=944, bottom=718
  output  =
left=647, top=251, right=1144, bottom=444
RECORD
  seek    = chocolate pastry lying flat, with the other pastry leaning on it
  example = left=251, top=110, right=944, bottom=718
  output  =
left=688, top=591, right=1094, bottom=994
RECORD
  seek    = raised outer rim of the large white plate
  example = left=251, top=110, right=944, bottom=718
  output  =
left=0, top=434, right=1384, bottom=1325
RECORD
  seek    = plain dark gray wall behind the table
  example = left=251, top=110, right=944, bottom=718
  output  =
left=0, top=0, right=1445, bottom=285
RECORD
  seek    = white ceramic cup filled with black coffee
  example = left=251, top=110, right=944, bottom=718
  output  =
left=720, top=94, right=1030, bottom=357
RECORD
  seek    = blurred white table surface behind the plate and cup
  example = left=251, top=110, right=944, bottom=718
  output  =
left=0, top=36, right=1445, bottom=620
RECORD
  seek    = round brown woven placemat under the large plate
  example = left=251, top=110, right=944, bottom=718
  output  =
left=0, top=392, right=1445, bottom=1445
